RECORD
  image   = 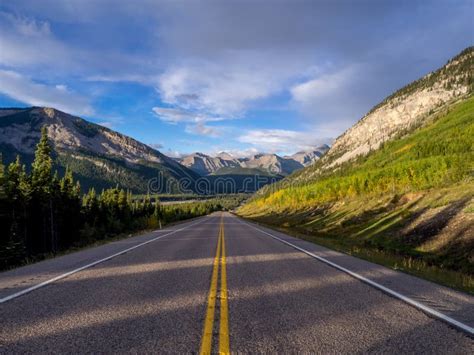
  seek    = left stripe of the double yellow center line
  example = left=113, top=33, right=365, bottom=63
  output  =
left=199, top=217, right=221, bottom=354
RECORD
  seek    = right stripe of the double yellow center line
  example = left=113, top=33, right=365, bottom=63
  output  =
left=219, top=219, right=230, bottom=354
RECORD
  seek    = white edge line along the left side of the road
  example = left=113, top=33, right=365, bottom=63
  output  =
left=0, top=218, right=205, bottom=304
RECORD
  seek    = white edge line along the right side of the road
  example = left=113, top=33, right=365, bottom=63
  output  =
left=238, top=218, right=474, bottom=335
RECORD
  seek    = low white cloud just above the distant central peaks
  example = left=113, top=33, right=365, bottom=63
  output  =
left=238, top=129, right=329, bottom=153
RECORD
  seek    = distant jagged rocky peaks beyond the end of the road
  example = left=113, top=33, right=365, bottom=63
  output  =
left=177, top=150, right=329, bottom=176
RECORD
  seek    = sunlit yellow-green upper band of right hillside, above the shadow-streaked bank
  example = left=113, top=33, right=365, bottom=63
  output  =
left=242, top=97, right=474, bottom=213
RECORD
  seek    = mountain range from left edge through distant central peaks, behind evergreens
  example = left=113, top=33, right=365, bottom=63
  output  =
left=0, top=107, right=322, bottom=194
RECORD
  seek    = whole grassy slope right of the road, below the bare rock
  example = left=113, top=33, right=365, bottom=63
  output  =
left=238, top=97, right=474, bottom=292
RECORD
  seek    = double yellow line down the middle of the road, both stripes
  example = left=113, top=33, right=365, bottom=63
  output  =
left=199, top=216, right=230, bottom=354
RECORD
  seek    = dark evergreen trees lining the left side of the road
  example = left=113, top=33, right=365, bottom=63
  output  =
left=0, top=129, right=244, bottom=269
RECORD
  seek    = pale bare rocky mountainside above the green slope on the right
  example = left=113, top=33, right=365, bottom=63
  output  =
left=323, top=47, right=474, bottom=171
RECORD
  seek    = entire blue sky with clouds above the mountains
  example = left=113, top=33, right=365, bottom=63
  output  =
left=0, top=0, right=474, bottom=156
